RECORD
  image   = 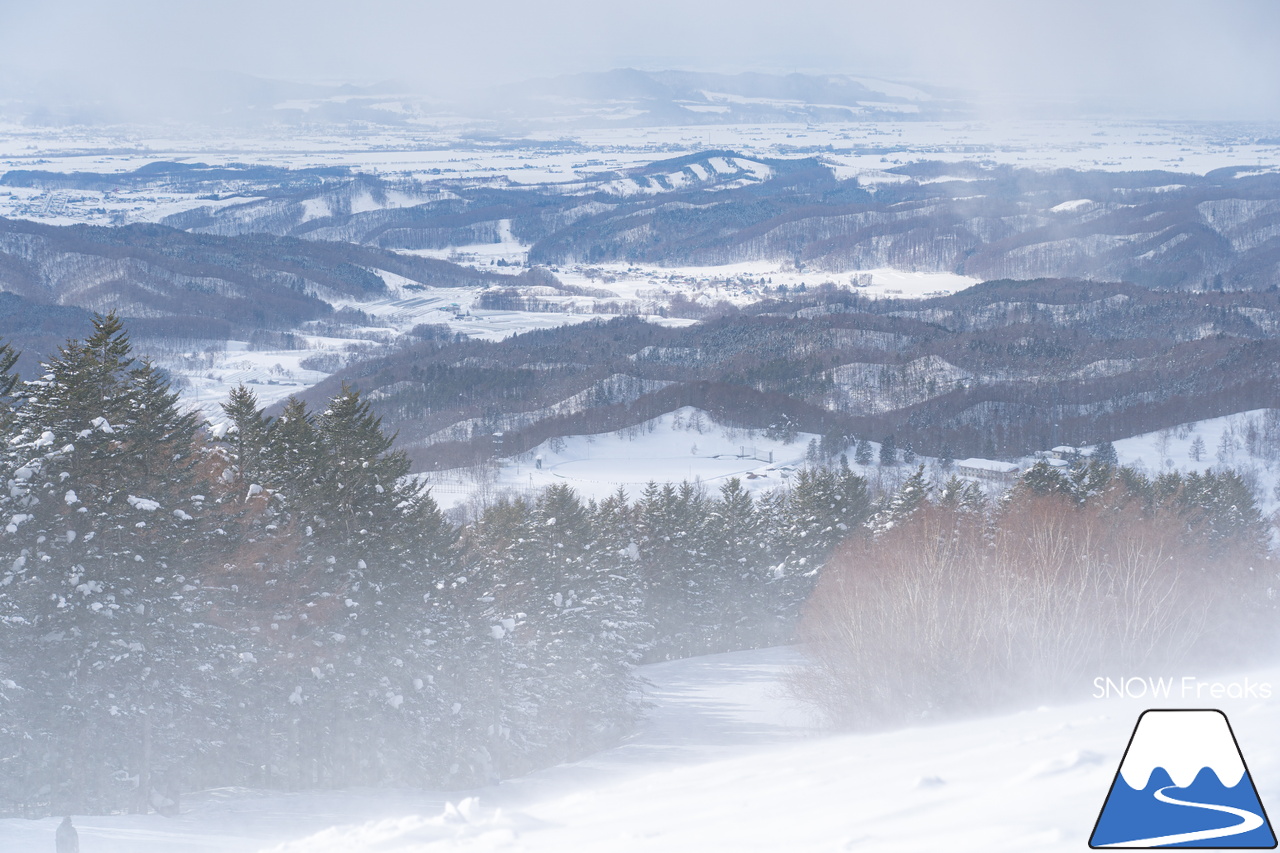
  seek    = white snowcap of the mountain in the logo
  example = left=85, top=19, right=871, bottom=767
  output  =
left=1120, top=711, right=1244, bottom=790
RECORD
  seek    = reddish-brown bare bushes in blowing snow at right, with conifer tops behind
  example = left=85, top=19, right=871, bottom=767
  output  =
left=792, top=461, right=1276, bottom=727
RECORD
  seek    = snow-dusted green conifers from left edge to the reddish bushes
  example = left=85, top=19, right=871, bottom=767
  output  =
left=0, top=315, right=874, bottom=816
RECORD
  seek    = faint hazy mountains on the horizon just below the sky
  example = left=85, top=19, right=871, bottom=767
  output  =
left=0, top=68, right=969, bottom=127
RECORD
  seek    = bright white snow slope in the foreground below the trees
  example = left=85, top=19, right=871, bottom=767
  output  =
left=0, top=648, right=1280, bottom=853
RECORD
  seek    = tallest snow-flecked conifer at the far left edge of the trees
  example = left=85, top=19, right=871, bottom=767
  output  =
left=0, top=315, right=210, bottom=811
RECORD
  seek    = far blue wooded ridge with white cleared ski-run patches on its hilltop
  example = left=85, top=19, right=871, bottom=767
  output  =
left=70, top=156, right=1280, bottom=291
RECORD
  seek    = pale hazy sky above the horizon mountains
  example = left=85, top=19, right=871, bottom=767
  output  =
left=0, top=0, right=1280, bottom=120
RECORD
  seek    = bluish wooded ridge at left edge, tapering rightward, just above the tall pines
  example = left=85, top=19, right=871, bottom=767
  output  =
left=0, top=212, right=516, bottom=366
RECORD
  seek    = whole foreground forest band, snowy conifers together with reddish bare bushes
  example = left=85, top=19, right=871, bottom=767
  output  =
left=0, top=315, right=1275, bottom=817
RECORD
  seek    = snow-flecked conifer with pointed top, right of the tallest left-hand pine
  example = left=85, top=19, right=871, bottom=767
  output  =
left=241, top=386, right=457, bottom=784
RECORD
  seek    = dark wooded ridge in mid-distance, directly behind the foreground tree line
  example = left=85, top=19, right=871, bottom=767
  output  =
left=311, top=279, right=1280, bottom=470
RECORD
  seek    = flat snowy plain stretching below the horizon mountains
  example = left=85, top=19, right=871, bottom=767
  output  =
left=0, top=119, right=1280, bottom=224
